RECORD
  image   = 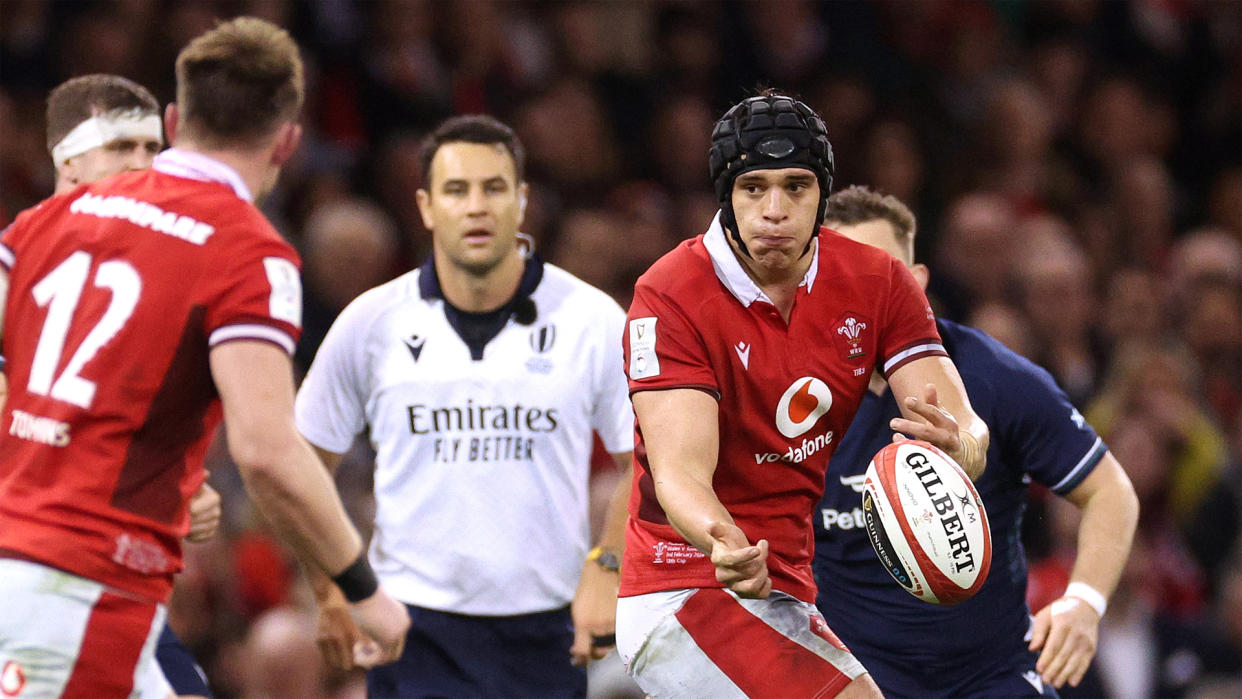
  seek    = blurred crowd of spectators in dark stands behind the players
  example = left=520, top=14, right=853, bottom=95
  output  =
left=0, top=0, right=1242, bottom=698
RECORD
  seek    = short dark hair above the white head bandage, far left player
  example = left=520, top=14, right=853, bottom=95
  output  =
left=47, top=73, right=159, bottom=153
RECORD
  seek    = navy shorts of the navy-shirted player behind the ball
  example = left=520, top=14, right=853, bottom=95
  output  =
left=851, top=643, right=1059, bottom=699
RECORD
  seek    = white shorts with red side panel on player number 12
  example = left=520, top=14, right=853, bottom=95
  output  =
left=0, top=559, right=173, bottom=699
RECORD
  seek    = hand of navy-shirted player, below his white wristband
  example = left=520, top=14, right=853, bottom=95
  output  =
left=1028, top=597, right=1099, bottom=689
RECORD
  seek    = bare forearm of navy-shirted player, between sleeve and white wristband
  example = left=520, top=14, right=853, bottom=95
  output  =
left=1069, top=456, right=1139, bottom=598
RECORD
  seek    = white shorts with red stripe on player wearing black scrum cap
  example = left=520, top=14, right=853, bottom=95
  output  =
left=617, top=589, right=866, bottom=699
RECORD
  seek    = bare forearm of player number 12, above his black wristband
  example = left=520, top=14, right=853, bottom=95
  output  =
left=235, top=436, right=363, bottom=576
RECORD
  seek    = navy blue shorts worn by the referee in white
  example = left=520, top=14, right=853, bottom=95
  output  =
left=366, top=605, right=586, bottom=699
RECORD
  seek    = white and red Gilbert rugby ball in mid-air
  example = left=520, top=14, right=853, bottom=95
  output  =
left=862, top=440, right=992, bottom=605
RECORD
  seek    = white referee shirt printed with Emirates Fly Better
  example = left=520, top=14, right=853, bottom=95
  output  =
left=296, top=258, right=633, bottom=616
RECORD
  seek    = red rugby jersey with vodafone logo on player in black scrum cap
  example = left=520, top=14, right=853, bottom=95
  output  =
left=621, top=217, right=945, bottom=603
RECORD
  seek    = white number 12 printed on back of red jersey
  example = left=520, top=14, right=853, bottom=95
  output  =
left=26, top=250, right=143, bottom=408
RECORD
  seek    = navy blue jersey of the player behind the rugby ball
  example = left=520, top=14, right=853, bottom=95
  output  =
left=815, top=320, right=1107, bottom=697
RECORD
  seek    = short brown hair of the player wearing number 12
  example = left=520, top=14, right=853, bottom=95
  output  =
left=176, top=17, right=306, bottom=148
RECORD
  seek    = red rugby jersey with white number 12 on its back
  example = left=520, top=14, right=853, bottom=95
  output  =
left=0, top=150, right=302, bottom=601
